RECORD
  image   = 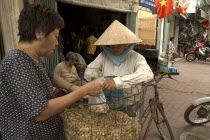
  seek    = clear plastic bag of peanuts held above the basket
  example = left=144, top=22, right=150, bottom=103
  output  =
left=88, top=77, right=109, bottom=113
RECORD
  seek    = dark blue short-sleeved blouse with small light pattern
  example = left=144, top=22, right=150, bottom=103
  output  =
left=0, top=50, right=63, bottom=140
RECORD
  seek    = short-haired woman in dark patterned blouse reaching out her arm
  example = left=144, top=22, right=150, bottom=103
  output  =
left=0, top=4, right=101, bottom=140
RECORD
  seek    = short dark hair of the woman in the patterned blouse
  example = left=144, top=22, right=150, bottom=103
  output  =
left=18, top=4, right=64, bottom=42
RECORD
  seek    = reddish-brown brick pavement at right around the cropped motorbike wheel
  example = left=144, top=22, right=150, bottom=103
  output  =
left=146, top=59, right=210, bottom=140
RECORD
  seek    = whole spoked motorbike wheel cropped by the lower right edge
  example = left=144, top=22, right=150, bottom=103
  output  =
left=184, top=102, right=210, bottom=125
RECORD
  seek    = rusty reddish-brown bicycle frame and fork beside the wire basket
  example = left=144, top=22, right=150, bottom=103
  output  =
left=142, top=83, right=160, bottom=140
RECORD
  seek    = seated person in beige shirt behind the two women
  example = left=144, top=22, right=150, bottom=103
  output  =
left=54, top=52, right=80, bottom=84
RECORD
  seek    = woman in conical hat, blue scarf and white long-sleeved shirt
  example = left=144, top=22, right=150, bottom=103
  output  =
left=84, top=20, right=153, bottom=104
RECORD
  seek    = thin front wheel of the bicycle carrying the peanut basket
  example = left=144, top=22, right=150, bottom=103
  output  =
left=154, top=104, right=174, bottom=140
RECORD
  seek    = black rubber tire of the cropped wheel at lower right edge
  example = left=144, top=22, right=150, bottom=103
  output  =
left=184, top=102, right=210, bottom=125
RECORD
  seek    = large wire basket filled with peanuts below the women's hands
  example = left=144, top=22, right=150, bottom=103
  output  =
left=61, top=80, right=145, bottom=140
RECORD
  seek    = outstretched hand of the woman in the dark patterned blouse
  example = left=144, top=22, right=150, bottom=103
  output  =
left=82, top=81, right=102, bottom=96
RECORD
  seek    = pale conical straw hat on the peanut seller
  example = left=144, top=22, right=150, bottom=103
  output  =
left=94, top=20, right=142, bottom=45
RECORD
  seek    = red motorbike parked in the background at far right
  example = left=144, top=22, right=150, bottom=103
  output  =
left=186, top=42, right=210, bottom=62
